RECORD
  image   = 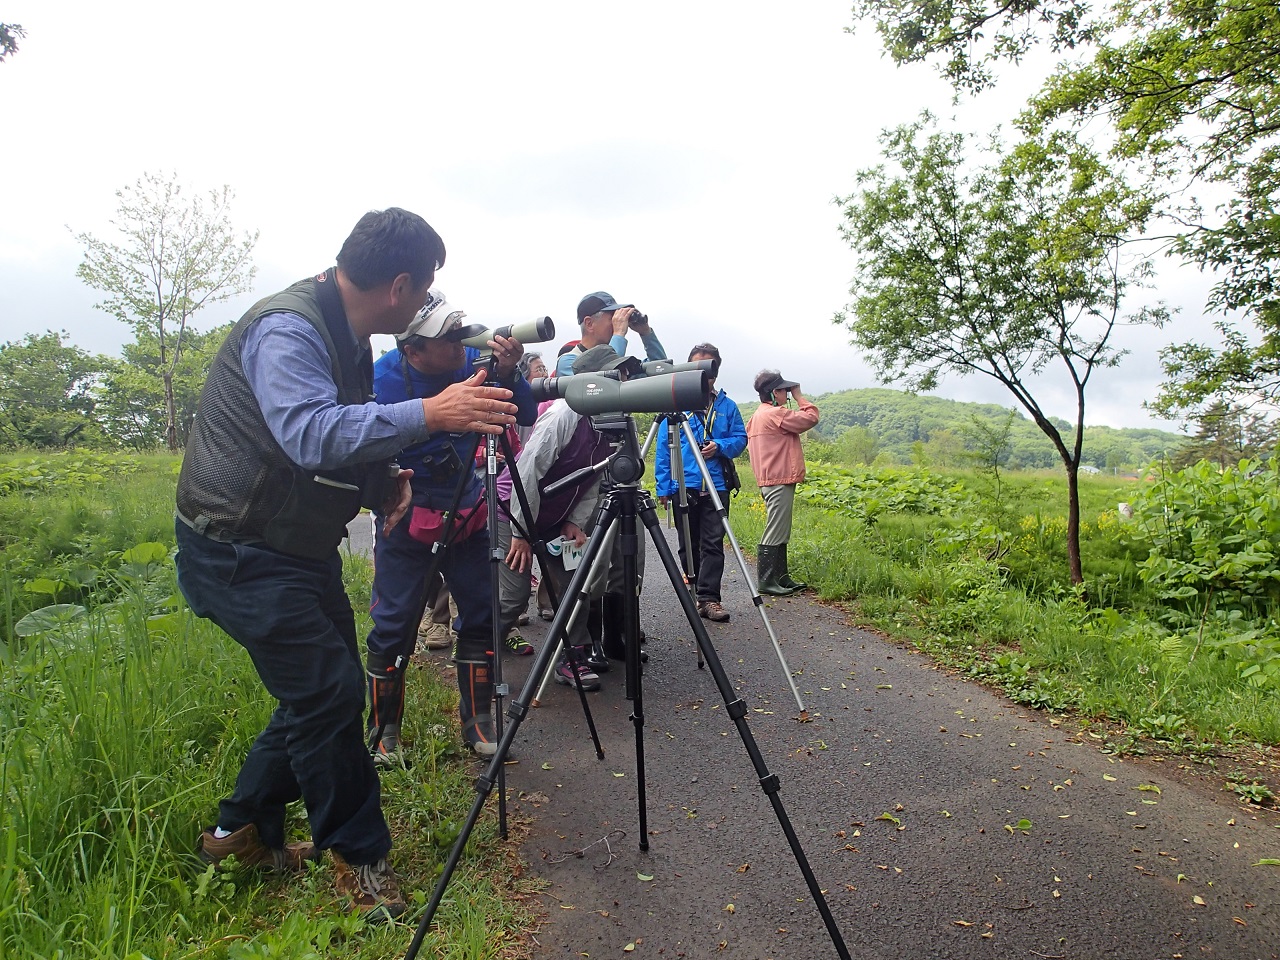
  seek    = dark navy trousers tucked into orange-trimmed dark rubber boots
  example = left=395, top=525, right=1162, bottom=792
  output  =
left=367, top=517, right=494, bottom=660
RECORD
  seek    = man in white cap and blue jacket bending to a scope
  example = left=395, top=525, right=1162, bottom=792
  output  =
left=367, top=289, right=538, bottom=758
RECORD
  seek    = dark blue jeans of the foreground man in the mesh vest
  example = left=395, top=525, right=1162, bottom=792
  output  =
left=177, top=521, right=392, bottom=864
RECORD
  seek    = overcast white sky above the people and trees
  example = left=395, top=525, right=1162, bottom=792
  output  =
left=0, top=0, right=1208, bottom=426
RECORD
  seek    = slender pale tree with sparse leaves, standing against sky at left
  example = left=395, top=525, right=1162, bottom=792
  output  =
left=76, top=173, right=259, bottom=451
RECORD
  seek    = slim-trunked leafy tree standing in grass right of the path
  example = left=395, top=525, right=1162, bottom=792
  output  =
left=836, top=114, right=1166, bottom=584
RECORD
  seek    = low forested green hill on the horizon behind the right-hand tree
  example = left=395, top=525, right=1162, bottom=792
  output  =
left=740, top=387, right=1188, bottom=471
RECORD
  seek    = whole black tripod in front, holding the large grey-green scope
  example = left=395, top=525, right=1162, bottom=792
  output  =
left=406, top=416, right=850, bottom=960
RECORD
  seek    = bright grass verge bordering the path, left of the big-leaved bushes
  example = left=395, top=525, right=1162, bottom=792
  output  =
left=731, top=470, right=1280, bottom=749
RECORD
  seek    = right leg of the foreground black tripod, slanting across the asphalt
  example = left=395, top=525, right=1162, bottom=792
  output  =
left=628, top=494, right=850, bottom=960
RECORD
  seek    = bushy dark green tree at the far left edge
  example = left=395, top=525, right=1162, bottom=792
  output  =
left=0, top=330, right=113, bottom=448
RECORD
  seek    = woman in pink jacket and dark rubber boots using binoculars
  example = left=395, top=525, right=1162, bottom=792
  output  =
left=746, top=370, right=818, bottom=596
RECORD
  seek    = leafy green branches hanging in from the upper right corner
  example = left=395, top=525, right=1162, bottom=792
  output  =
left=854, top=0, right=1280, bottom=416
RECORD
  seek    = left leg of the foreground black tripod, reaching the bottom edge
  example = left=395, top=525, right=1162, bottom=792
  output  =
left=404, top=497, right=613, bottom=960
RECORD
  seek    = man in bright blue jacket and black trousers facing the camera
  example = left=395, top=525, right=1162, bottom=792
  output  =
left=654, top=343, right=746, bottom=623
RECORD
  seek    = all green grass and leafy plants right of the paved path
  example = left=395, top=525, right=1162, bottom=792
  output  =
left=732, top=461, right=1280, bottom=804
